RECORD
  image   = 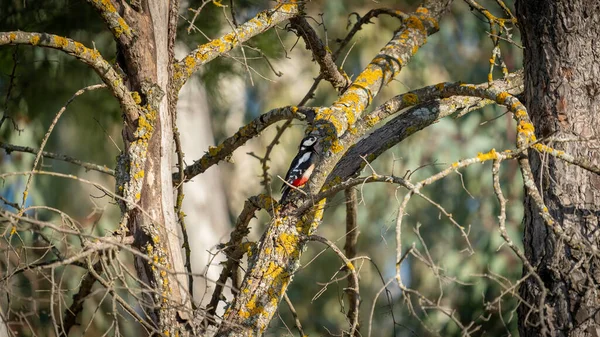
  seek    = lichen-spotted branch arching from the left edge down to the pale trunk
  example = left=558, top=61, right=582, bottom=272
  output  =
left=0, top=31, right=138, bottom=120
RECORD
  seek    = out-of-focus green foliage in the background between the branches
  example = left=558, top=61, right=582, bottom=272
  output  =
left=0, top=0, right=522, bottom=336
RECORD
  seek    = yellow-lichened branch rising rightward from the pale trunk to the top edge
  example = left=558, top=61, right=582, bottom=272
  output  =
left=173, top=2, right=300, bottom=90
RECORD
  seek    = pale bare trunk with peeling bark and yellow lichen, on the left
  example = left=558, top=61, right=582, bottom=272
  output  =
left=112, top=1, right=191, bottom=335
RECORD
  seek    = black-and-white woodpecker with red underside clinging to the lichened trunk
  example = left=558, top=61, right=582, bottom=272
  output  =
left=280, top=136, right=317, bottom=202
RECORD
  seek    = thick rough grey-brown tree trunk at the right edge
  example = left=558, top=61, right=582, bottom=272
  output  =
left=516, top=0, right=600, bottom=337
